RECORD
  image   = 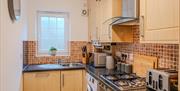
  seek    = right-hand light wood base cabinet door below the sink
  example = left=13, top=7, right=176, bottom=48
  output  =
left=61, top=70, right=83, bottom=91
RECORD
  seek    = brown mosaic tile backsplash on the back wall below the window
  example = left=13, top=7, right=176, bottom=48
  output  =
left=23, top=41, right=92, bottom=64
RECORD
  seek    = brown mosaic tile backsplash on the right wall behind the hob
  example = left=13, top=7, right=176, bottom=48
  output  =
left=114, top=26, right=179, bottom=70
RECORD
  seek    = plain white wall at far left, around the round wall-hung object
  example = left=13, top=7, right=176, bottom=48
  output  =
left=0, top=0, right=27, bottom=91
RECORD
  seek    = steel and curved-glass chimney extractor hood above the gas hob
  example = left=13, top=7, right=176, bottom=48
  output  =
left=104, top=0, right=139, bottom=25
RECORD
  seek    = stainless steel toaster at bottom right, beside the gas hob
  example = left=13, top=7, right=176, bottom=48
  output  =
left=146, top=68, right=178, bottom=91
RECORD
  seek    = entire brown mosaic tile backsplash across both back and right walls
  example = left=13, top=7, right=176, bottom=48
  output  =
left=23, top=26, right=179, bottom=70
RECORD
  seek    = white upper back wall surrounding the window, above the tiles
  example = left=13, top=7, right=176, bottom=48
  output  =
left=28, top=0, right=88, bottom=41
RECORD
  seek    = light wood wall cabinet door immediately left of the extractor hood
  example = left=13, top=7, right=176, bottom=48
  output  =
left=100, top=0, right=122, bottom=42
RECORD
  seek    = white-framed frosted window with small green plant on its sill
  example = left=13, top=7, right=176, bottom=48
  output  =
left=37, top=12, right=69, bottom=56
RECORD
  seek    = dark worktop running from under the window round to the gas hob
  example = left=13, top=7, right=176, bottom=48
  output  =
left=23, top=64, right=153, bottom=91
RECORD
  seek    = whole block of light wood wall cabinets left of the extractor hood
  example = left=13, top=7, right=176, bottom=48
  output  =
left=88, top=0, right=132, bottom=42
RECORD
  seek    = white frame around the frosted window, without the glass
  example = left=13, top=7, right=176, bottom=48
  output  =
left=36, top=11, right=70, bottom=56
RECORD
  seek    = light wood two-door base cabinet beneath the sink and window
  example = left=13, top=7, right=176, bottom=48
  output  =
left=23, top=70, right=86, bottom=91
